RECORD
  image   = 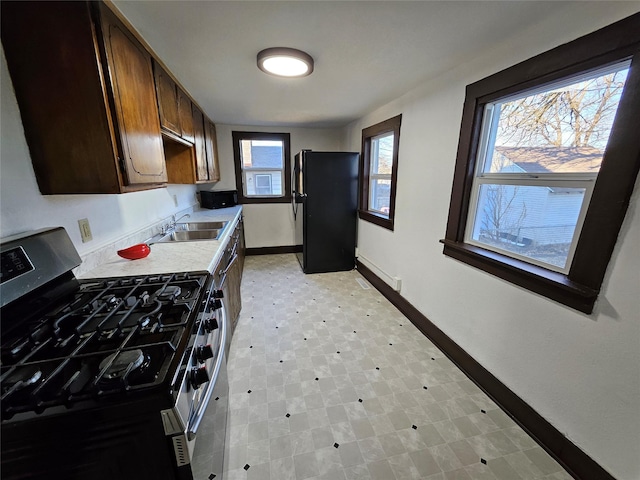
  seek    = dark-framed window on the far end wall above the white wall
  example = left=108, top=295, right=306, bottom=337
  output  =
left=232, top=131, right=291, bottom=203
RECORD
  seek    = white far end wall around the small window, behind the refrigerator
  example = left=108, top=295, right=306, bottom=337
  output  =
left=208, top=125, right=342, bottom=248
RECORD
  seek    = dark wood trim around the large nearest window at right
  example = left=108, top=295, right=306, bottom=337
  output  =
left=441, top=14, right=640, bottom=313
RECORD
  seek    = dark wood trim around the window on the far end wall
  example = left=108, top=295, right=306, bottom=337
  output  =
left=231, top=131, right=291, bottom=204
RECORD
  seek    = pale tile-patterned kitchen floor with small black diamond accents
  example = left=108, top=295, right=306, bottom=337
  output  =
left=225, top=255, right=571, bottom=480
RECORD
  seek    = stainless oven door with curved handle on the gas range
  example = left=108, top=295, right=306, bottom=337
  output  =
left=187, top=306, right=229, bottom=480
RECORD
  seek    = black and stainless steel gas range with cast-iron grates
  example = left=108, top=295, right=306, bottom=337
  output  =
left=0, top=228, right=229, bottom=480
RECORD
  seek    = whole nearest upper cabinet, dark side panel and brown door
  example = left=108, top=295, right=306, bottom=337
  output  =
left=0, top=1, right=167, bottom=194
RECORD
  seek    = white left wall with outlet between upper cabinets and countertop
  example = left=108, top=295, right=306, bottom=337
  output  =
left=0, top=47, right=196, bottom=258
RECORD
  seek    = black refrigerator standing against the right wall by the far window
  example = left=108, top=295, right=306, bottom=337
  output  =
left=292, top=150, right=359, bottom=273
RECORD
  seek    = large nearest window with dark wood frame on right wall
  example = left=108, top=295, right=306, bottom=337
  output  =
left=442, top=15, right=640, bottom=313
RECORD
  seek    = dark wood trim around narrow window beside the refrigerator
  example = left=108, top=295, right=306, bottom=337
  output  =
left=358, top=115, right=402, bottom=230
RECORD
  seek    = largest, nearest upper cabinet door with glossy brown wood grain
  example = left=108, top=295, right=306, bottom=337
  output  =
left=101, top=7, right=167, bottom=185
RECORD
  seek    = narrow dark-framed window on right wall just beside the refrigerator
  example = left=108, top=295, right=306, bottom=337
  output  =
left=359, top=115, right=402, bottom=230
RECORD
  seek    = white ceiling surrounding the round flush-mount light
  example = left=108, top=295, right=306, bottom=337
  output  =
left=114, top=0, right=632, bottom=127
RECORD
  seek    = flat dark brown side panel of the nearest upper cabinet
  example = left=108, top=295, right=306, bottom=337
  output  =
left=0, top=2, right=121, bottom=195
